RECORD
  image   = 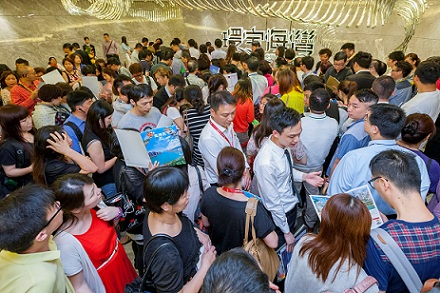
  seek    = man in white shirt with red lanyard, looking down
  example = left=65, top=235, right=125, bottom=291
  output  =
left=199, top=91, right=251, bottom=190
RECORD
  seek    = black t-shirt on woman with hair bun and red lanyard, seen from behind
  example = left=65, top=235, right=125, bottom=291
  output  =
left=200, top=186, right=275, bottom=254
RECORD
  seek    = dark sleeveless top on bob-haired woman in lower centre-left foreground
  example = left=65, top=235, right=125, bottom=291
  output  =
left=143, top=211, right=201, bottom=293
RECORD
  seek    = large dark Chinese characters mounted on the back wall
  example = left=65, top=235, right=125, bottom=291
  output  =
left=223, top=26, right=315, bottom=56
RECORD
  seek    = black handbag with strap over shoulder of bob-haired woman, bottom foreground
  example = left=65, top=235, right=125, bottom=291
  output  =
left=124, top=234, right=180, bottom=293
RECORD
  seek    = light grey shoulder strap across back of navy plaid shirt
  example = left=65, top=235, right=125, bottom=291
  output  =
left=371, top=228, right=423, bottom=292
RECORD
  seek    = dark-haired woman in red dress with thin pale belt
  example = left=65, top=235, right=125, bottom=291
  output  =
left=53, top=174, right=137, bottom=293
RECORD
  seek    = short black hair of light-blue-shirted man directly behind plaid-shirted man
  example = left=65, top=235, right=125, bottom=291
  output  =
left=368, top=104, right=406, bottom=139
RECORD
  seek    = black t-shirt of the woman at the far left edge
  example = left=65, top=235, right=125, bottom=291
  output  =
left=0, top=139, right=34, bottom=198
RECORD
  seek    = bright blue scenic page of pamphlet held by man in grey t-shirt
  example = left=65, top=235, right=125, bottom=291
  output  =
left=141, top=125, right=186, bottom=166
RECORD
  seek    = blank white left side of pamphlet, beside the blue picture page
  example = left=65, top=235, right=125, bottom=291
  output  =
left=115, top=129, right=151, bottom=168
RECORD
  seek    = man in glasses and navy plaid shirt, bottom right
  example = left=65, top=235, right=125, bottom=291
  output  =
left=364, top=150, right=440, bottom=293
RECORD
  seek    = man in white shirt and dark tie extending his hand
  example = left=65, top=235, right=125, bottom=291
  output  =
left=254, top=108, right=324, bottom=252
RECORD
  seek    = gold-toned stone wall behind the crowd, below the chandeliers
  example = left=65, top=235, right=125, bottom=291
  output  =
left=0, top=0, right=440, bottom=67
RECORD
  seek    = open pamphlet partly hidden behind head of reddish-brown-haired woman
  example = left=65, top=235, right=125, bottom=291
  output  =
left=310, top=185, right=383, bottom=229
